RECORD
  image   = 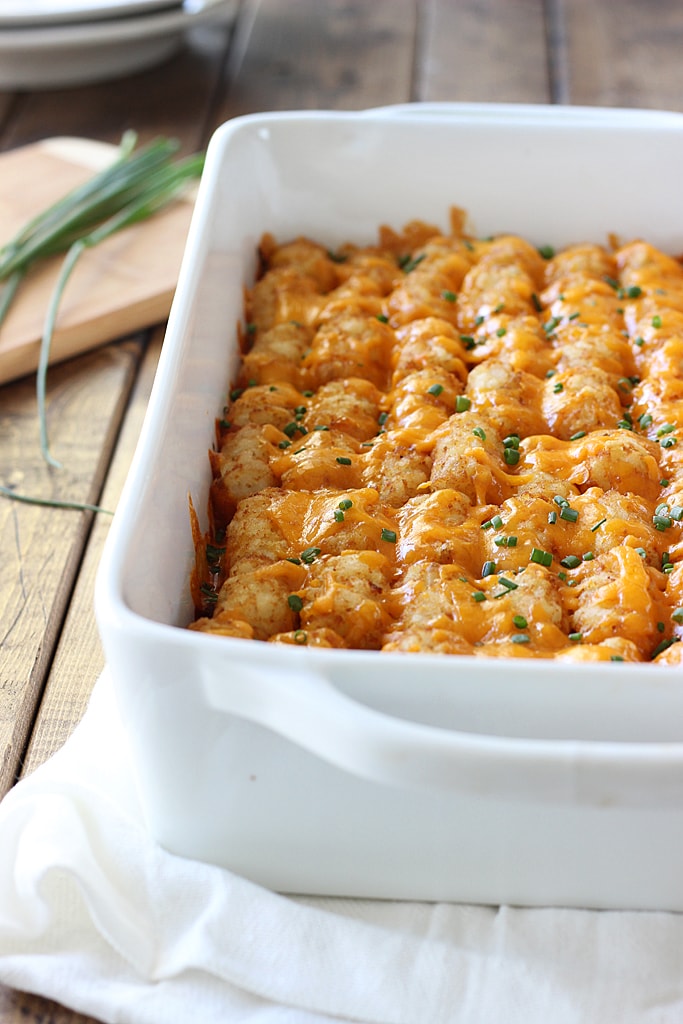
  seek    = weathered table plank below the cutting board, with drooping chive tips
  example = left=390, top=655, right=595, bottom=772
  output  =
left=0, top=340, right=141, bottom=796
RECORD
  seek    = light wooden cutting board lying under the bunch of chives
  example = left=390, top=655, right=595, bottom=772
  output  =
left=0, top=138, right=194, bottom=383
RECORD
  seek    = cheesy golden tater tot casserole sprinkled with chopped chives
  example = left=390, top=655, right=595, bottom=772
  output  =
left=190, top=210, right=683, bottom=665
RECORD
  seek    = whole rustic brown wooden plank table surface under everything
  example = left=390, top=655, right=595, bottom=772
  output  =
left=0, top=0, right=683, bottom=1024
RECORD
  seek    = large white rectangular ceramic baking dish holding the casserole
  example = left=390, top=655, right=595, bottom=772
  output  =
left=96, top=104, right=683, bottom=910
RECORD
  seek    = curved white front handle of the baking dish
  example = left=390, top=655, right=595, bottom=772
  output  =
left=198, top=667, right=683, bottom=808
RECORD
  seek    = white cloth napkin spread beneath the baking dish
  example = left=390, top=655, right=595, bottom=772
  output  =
left=0, top=674, right=683, bottom=1024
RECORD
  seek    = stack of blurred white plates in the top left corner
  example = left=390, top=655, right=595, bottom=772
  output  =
left=0, top=0, right=238, bottom=89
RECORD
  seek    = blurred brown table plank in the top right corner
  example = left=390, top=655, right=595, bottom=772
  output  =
left=549, top=0, right=683, bottom=111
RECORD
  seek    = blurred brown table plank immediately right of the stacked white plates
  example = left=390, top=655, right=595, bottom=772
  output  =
left=213, top=0, right=417, bottom=126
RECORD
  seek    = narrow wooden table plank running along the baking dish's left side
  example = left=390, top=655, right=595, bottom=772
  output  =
left=22, top=328, right=164, bottom=775
